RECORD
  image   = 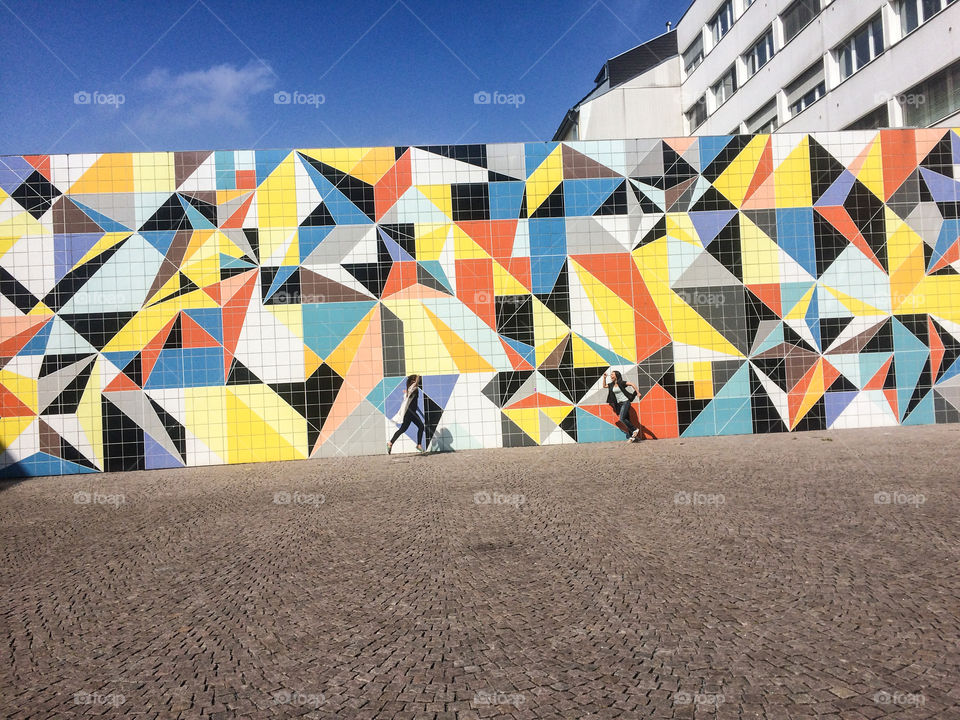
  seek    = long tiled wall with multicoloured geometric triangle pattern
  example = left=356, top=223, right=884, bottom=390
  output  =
left=0, top=129, right=960, bottom=476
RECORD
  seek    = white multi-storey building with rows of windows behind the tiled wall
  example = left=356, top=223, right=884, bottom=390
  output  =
left=554, top=0, right=960, bottom=140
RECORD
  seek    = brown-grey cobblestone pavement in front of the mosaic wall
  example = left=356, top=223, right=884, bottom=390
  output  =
left=0, top=426, right=960, bottom=720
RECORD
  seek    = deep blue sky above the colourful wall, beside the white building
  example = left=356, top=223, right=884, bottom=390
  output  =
left=0, top=0, right=688, bottom=154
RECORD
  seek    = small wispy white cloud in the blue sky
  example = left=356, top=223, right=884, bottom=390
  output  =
left=138, top=63, right=275, bottom=131
